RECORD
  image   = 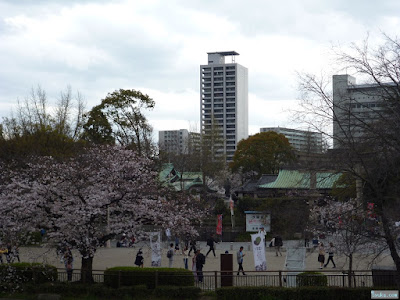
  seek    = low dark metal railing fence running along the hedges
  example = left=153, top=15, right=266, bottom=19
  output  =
left=54, top=269, right=397, bottom=291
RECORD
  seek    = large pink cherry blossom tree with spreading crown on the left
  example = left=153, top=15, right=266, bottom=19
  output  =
left=0, top=146, right=203, bottom=282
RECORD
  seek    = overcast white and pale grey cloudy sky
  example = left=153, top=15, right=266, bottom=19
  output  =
left=0, top=0, right=400, bottom=138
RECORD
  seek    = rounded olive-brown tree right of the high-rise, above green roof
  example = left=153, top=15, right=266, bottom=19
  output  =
left=230, top=131, right=295, bottom=177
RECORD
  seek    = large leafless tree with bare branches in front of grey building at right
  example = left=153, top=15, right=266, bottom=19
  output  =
left=295, top=35, right=400, bottom=282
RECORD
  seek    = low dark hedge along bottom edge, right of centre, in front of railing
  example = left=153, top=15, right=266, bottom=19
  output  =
left=217, top=287, right=371, bottom=300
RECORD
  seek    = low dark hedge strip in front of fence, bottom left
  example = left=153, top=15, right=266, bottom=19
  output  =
left=18, top=283, right=201, bottom=299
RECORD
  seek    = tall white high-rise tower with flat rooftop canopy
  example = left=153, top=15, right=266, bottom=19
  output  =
left=200, top=51, right=248, bottom=161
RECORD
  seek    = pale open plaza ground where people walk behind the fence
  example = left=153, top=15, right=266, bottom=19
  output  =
left=16, top=241, right=394, bottom=271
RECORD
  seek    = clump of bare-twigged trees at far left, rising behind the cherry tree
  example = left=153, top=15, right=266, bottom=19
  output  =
left=0, top=86, right=85, bottom=159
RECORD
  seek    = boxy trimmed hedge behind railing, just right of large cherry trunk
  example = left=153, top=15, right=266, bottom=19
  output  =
left=104, top=267, right=194, bottom=289
